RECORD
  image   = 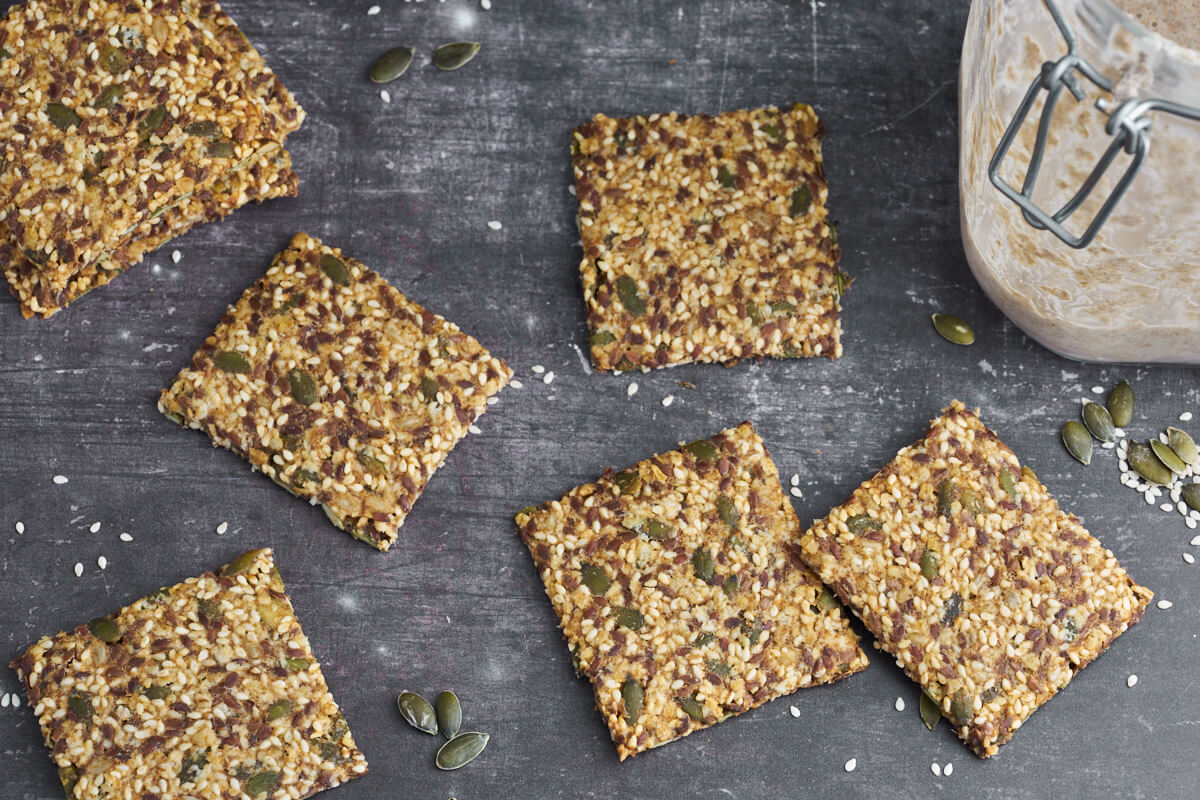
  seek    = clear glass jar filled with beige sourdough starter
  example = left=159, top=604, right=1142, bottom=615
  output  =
left=959, top=0, right=1200, bottom=363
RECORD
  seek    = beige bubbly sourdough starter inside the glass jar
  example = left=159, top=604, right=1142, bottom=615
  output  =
left=959, top=0, right=1200, bottom=363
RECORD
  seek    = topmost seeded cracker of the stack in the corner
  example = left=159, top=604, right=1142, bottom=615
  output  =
left=0, top=0, right=302, bottom=303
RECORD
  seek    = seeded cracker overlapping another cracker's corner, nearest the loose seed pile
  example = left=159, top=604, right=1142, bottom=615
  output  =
left=800, top=401, right=1152, bottom=758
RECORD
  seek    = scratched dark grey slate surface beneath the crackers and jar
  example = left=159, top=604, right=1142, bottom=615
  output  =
left=0, top=0, right=1200, bottom=799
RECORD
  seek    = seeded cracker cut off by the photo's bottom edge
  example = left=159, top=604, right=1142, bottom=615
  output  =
left=11, top=549, right=367, bottom=800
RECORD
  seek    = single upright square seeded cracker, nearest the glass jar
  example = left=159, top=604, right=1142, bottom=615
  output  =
left=572, top=103, right=848, bottom=372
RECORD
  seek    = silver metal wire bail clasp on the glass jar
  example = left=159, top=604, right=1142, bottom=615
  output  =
left=988, top=0, right=1200, bottom=248
